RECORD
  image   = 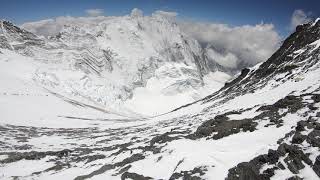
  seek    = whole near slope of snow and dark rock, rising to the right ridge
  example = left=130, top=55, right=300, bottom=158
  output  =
left=0, top=17, right=320, bottom=180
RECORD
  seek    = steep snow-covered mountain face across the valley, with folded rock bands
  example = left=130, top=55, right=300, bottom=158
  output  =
left=1, top=9, right=229, bottom=115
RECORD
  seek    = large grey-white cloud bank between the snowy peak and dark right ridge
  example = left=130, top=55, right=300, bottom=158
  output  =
left=180, top=21, right=281, bottom=69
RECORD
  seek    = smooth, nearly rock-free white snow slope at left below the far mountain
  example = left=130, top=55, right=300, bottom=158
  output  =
left=0, top=50, right=132, bottom=128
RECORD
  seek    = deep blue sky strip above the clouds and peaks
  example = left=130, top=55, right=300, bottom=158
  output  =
left=0, top=0, right=320, bottom=34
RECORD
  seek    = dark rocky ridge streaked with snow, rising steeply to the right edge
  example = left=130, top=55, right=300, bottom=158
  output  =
left=203, top=18, right=320, bottom=102
